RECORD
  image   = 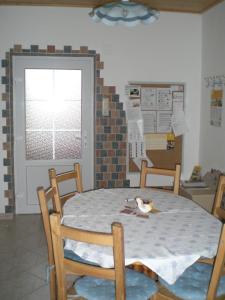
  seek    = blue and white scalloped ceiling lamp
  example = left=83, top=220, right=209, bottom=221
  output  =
left=89, top=0, right=159, bottom=27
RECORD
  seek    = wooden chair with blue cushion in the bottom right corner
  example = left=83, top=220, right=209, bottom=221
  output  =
left=157, top=225, right=225, bottom=300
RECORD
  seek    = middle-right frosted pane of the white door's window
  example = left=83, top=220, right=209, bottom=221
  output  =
left=55, top=101, right=81, bottom=131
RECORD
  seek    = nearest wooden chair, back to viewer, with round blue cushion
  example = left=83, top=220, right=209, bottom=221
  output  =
left=50, top=214, right=157, bottom=300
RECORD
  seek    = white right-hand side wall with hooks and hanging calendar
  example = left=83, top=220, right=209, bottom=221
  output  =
left=200, top=1, right=225, bottom=171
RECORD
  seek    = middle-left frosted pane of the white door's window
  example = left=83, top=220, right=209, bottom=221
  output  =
left=26, top=101, right=53, bottom=129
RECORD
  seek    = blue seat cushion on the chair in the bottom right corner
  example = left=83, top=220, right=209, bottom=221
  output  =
left=159, top=263, right=225, bottom=300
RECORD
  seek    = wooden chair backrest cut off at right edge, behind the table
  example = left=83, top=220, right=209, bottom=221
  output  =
left=212, top=175, right=225, bottom=220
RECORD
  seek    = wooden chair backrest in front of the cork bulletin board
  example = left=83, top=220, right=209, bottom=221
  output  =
left=140, top=160, right=181, bottom=195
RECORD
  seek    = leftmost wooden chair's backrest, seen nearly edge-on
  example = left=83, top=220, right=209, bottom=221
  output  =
left=37, top=187, right=57, bottom=300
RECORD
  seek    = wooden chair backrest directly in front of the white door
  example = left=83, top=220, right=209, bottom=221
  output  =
left=49, top=163, right=83, bottom=217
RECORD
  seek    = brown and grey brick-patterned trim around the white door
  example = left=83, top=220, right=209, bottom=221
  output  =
left=1, top=45, right=130, bottom=215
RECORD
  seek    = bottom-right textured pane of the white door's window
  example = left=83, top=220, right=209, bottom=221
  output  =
left=55, top=131, right=81, bottom=159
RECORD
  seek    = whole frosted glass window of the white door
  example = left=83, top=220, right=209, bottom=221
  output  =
left=25, top=69, right=82, bottom=160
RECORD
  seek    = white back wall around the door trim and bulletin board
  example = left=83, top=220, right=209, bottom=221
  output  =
left=0, top=6, right=201, bottom=212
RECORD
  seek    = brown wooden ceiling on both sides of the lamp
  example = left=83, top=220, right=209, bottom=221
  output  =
left=0, top=0, right=223, bottom=13
